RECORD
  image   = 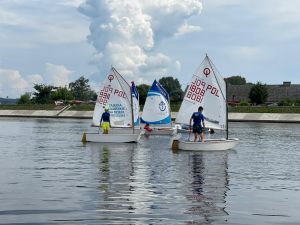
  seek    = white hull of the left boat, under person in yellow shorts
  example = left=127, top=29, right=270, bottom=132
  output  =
left=82, top=133, right=140, bottom=143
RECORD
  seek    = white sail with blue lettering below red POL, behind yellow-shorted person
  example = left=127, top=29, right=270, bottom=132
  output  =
left=93, top=68, right=132, bottom=127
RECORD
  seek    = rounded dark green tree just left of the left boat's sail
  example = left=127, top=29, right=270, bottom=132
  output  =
left=69, top=76, right=95, bottom=100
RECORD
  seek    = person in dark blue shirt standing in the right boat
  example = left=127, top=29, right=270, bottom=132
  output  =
left=190, top=106, right=205, bottom=142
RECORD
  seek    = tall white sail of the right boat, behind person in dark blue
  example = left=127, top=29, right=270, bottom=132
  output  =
left=175, top=56, right=227, bottom=130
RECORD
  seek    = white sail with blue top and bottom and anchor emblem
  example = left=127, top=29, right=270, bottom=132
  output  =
left=141, top=80, right=171, bottom=125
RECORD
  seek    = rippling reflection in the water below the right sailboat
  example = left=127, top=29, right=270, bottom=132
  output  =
left=186, top=152, right=228, bottom=224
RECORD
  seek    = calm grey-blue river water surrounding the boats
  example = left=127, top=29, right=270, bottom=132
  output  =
left=0, top=118, right=300, bottom=224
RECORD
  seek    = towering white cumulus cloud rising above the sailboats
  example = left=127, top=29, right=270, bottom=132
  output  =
left=79, top=0, right=202, bottom=80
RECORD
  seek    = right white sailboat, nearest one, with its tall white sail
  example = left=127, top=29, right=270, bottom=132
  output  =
left=170, top=55, right=238, bottom=151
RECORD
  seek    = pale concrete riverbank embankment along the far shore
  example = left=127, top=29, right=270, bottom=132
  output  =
left=0, top=110, right=300, bottom=123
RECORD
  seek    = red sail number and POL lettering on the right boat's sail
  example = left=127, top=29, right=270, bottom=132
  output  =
left=186, top=78, right=219, bottom=103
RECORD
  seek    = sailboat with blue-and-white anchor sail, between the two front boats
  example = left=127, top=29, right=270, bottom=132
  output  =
left=141, top=80, right=176, bottom=135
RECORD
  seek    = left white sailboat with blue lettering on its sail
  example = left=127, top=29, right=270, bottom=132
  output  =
left=82, top=67, right=140, bottom=143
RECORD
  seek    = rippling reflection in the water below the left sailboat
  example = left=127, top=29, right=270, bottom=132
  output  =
left=91, top=144, right=137, bottom=221
